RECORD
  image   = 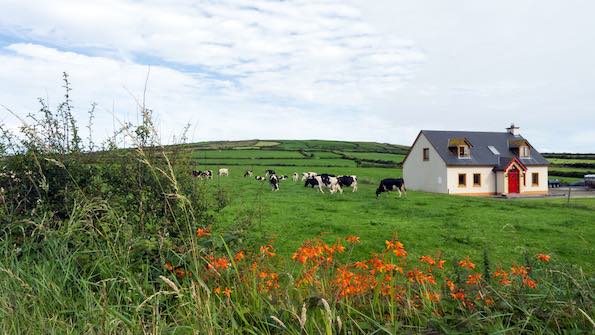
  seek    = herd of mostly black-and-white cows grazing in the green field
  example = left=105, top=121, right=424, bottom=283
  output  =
left=192, top=168, right=406, bottom=197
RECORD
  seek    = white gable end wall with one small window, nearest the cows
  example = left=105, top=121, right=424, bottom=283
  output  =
left=403, top=134, right=447, bottom=193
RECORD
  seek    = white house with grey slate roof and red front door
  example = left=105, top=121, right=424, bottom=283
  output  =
left=403, top=124, right=549, bottom=196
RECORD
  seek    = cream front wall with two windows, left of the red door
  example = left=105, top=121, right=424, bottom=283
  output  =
left=446, top=166, right=496, bottom=195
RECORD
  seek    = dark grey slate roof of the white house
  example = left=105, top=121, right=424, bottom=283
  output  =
left=421, top=130, right=549, bottom=169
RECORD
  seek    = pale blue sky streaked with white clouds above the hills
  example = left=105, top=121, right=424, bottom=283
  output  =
left=0, top=0, right=595, bottom=152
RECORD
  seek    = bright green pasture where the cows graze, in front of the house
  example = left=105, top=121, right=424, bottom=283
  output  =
left=193, top=166, right=595, bottom=271
